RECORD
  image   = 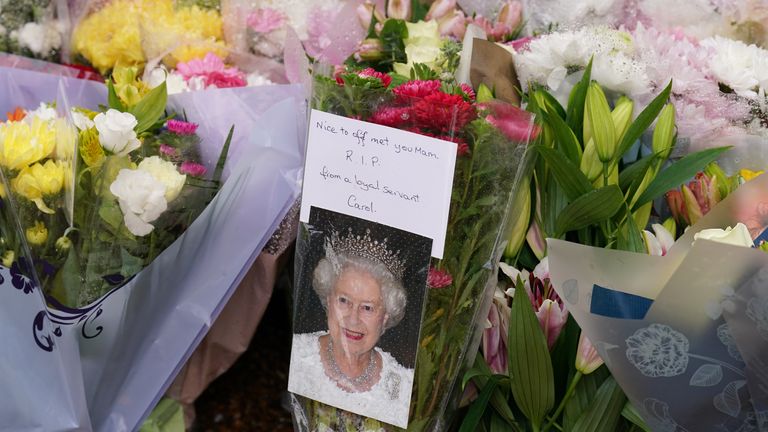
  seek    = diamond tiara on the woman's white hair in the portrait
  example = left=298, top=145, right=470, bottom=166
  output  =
left=325, top=228, right=405, bottom=280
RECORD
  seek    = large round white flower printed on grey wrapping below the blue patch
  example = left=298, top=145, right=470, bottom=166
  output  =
left=626, top=324, right=690, bottom=378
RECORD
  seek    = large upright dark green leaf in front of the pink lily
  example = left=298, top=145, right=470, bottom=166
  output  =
left=507, top=276, right=555, bottom=425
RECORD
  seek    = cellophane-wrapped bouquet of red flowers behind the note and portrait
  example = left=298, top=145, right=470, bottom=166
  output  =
left=295, top=59, right=536, bottom=430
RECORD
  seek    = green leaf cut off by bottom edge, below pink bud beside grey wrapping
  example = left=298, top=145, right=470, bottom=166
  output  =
left=573, top=377, right=627, bottom=432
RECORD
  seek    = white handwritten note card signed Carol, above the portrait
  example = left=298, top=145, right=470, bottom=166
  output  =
left=299, top=110, right=456, bottom=258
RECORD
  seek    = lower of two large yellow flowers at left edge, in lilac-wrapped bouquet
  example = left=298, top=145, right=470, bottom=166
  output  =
left=11, top=160, right=64, bottom=214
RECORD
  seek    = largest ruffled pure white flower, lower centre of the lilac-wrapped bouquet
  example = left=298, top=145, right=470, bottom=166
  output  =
left=109, top=169, right=168, bottom=236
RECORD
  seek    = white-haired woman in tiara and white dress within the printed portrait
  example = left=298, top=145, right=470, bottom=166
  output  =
left=288, top=208, right=432, bottom=427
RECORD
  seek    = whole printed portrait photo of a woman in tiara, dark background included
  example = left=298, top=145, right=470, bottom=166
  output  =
left=288, top=207, right=432, bottom=427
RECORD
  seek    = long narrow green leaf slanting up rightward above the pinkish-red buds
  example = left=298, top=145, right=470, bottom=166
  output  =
left=633, top=147, right=730, bottom=210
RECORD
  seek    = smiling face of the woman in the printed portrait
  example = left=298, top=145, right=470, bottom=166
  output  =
left=328, top=268, right=387, bottom=356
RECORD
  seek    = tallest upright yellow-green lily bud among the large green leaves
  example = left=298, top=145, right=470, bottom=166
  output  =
left=584, top=83, right=616, bottom=163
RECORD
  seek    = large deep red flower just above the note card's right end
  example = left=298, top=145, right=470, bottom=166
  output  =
left=413, top=92, right=476, bottom=133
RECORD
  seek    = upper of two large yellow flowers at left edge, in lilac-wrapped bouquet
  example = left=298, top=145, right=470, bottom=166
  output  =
left=0, top=117, right=56, bottom=170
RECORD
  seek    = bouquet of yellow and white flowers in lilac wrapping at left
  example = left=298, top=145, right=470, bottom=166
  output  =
left=0, top=65, right=303, bottom=431
